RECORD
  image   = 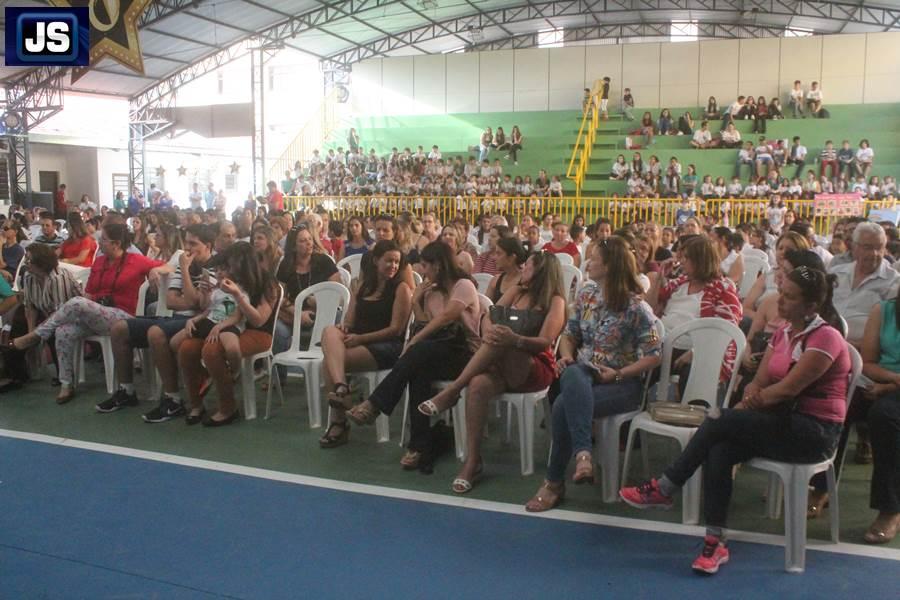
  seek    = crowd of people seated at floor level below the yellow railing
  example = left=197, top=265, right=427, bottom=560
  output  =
left=0, top=177, right=900, bottom=573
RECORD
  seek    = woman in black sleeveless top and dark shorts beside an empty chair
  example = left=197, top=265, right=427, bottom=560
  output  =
left=319, top=240, right=412, bottom=448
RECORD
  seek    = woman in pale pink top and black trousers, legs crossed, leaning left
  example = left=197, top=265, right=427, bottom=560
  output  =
left=347, top=242, right=481, bottom=470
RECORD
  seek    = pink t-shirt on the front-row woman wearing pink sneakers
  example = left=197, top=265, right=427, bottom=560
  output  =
left=769, top=318, right=850, bottom=423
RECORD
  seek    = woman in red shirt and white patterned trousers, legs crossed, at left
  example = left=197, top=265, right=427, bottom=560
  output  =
left=14, top=224, right=164, bottom=404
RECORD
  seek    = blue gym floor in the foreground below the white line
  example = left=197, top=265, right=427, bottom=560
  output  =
left=0, top=437, right=900, bottom=599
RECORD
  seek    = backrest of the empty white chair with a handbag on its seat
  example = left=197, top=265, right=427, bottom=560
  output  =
left=656, top=317, right=747, bottom=414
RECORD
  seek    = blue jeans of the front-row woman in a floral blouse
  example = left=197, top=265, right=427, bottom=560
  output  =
left=547, top=364, right=641, bottom=482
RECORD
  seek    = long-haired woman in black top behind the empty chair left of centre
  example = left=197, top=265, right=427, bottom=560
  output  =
left=273, top=224, right=341, bottom=364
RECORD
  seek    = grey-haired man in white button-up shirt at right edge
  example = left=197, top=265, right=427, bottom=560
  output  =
left=829, top=223, right=900, bottom=347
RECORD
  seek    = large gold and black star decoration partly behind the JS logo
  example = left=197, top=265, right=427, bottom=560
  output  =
left=50, top=0, right=153, bottom=82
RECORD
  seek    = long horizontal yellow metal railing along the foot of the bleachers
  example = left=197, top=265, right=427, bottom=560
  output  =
left=285, top=196, right=894, bottom=234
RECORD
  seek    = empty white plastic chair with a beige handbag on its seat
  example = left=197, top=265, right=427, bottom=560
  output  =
left=622, top=317, right=747, bottom=525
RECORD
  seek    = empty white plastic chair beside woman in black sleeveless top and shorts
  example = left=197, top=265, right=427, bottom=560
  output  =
left=266, top=281, right=350, bottom=429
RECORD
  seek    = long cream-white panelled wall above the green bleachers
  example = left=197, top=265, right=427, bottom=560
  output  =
left=351, top=32, right=900, bottom=115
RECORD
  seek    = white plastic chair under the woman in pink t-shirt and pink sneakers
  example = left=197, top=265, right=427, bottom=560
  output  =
left=744, top=344, right=863, bottom=573
